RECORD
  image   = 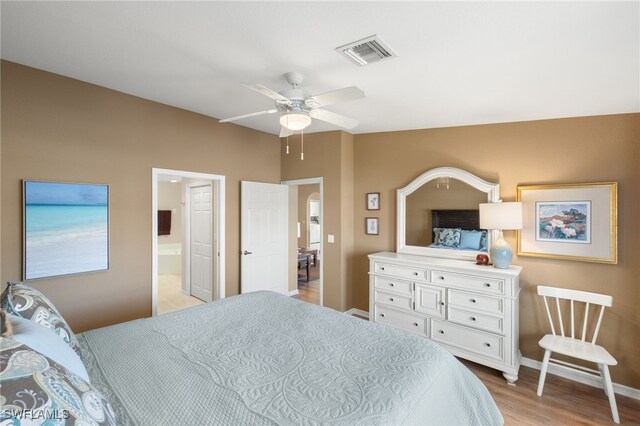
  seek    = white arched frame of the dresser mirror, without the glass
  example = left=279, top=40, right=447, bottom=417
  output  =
left=396, top=167, right=501, bottom=261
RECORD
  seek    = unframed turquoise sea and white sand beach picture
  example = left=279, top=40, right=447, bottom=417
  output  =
left=23, top=181, right=109, bottom=280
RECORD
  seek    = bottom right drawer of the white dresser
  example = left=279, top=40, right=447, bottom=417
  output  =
left=431, top=319, right=504, bottom=361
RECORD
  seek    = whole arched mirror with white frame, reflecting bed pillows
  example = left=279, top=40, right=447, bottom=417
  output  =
left=396, top=167, right=500, bottom=260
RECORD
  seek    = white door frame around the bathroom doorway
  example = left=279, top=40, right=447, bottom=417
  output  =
left=151, top=167, right=226, bottom=316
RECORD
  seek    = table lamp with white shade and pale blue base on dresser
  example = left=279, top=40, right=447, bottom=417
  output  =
left=480, top=202, right=522, bottom=269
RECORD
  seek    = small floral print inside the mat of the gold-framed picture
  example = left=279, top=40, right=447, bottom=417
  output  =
left=536, top=201, right=591, bottom=244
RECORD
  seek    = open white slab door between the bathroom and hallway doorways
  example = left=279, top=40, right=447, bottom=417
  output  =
left=240, top=182, right=289, bottom=294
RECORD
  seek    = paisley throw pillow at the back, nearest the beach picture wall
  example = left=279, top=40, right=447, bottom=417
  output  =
left=0, top=283, right=82, bottom=359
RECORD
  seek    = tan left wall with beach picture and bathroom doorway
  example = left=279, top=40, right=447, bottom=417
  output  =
left=1, top=61, right=280, bottom=331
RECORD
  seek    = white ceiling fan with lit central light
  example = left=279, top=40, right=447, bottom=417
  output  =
left=220, top=72, right=364, bottom=138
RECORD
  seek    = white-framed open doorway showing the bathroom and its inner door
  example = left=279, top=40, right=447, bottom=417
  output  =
left=152, top=169, right=225, bottom=315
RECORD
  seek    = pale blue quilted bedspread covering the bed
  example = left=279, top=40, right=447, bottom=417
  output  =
left=79, top=292, right=503, bottom=425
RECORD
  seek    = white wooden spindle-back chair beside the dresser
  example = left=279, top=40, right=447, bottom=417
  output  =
left=538, top=286, right=620, bottom=423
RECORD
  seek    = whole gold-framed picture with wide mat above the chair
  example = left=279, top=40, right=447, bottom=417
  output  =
left=516, top=182, right=618, bottom=264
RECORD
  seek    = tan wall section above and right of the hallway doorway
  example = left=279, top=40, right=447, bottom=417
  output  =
left=281, top=131, right=353, bottom=310
